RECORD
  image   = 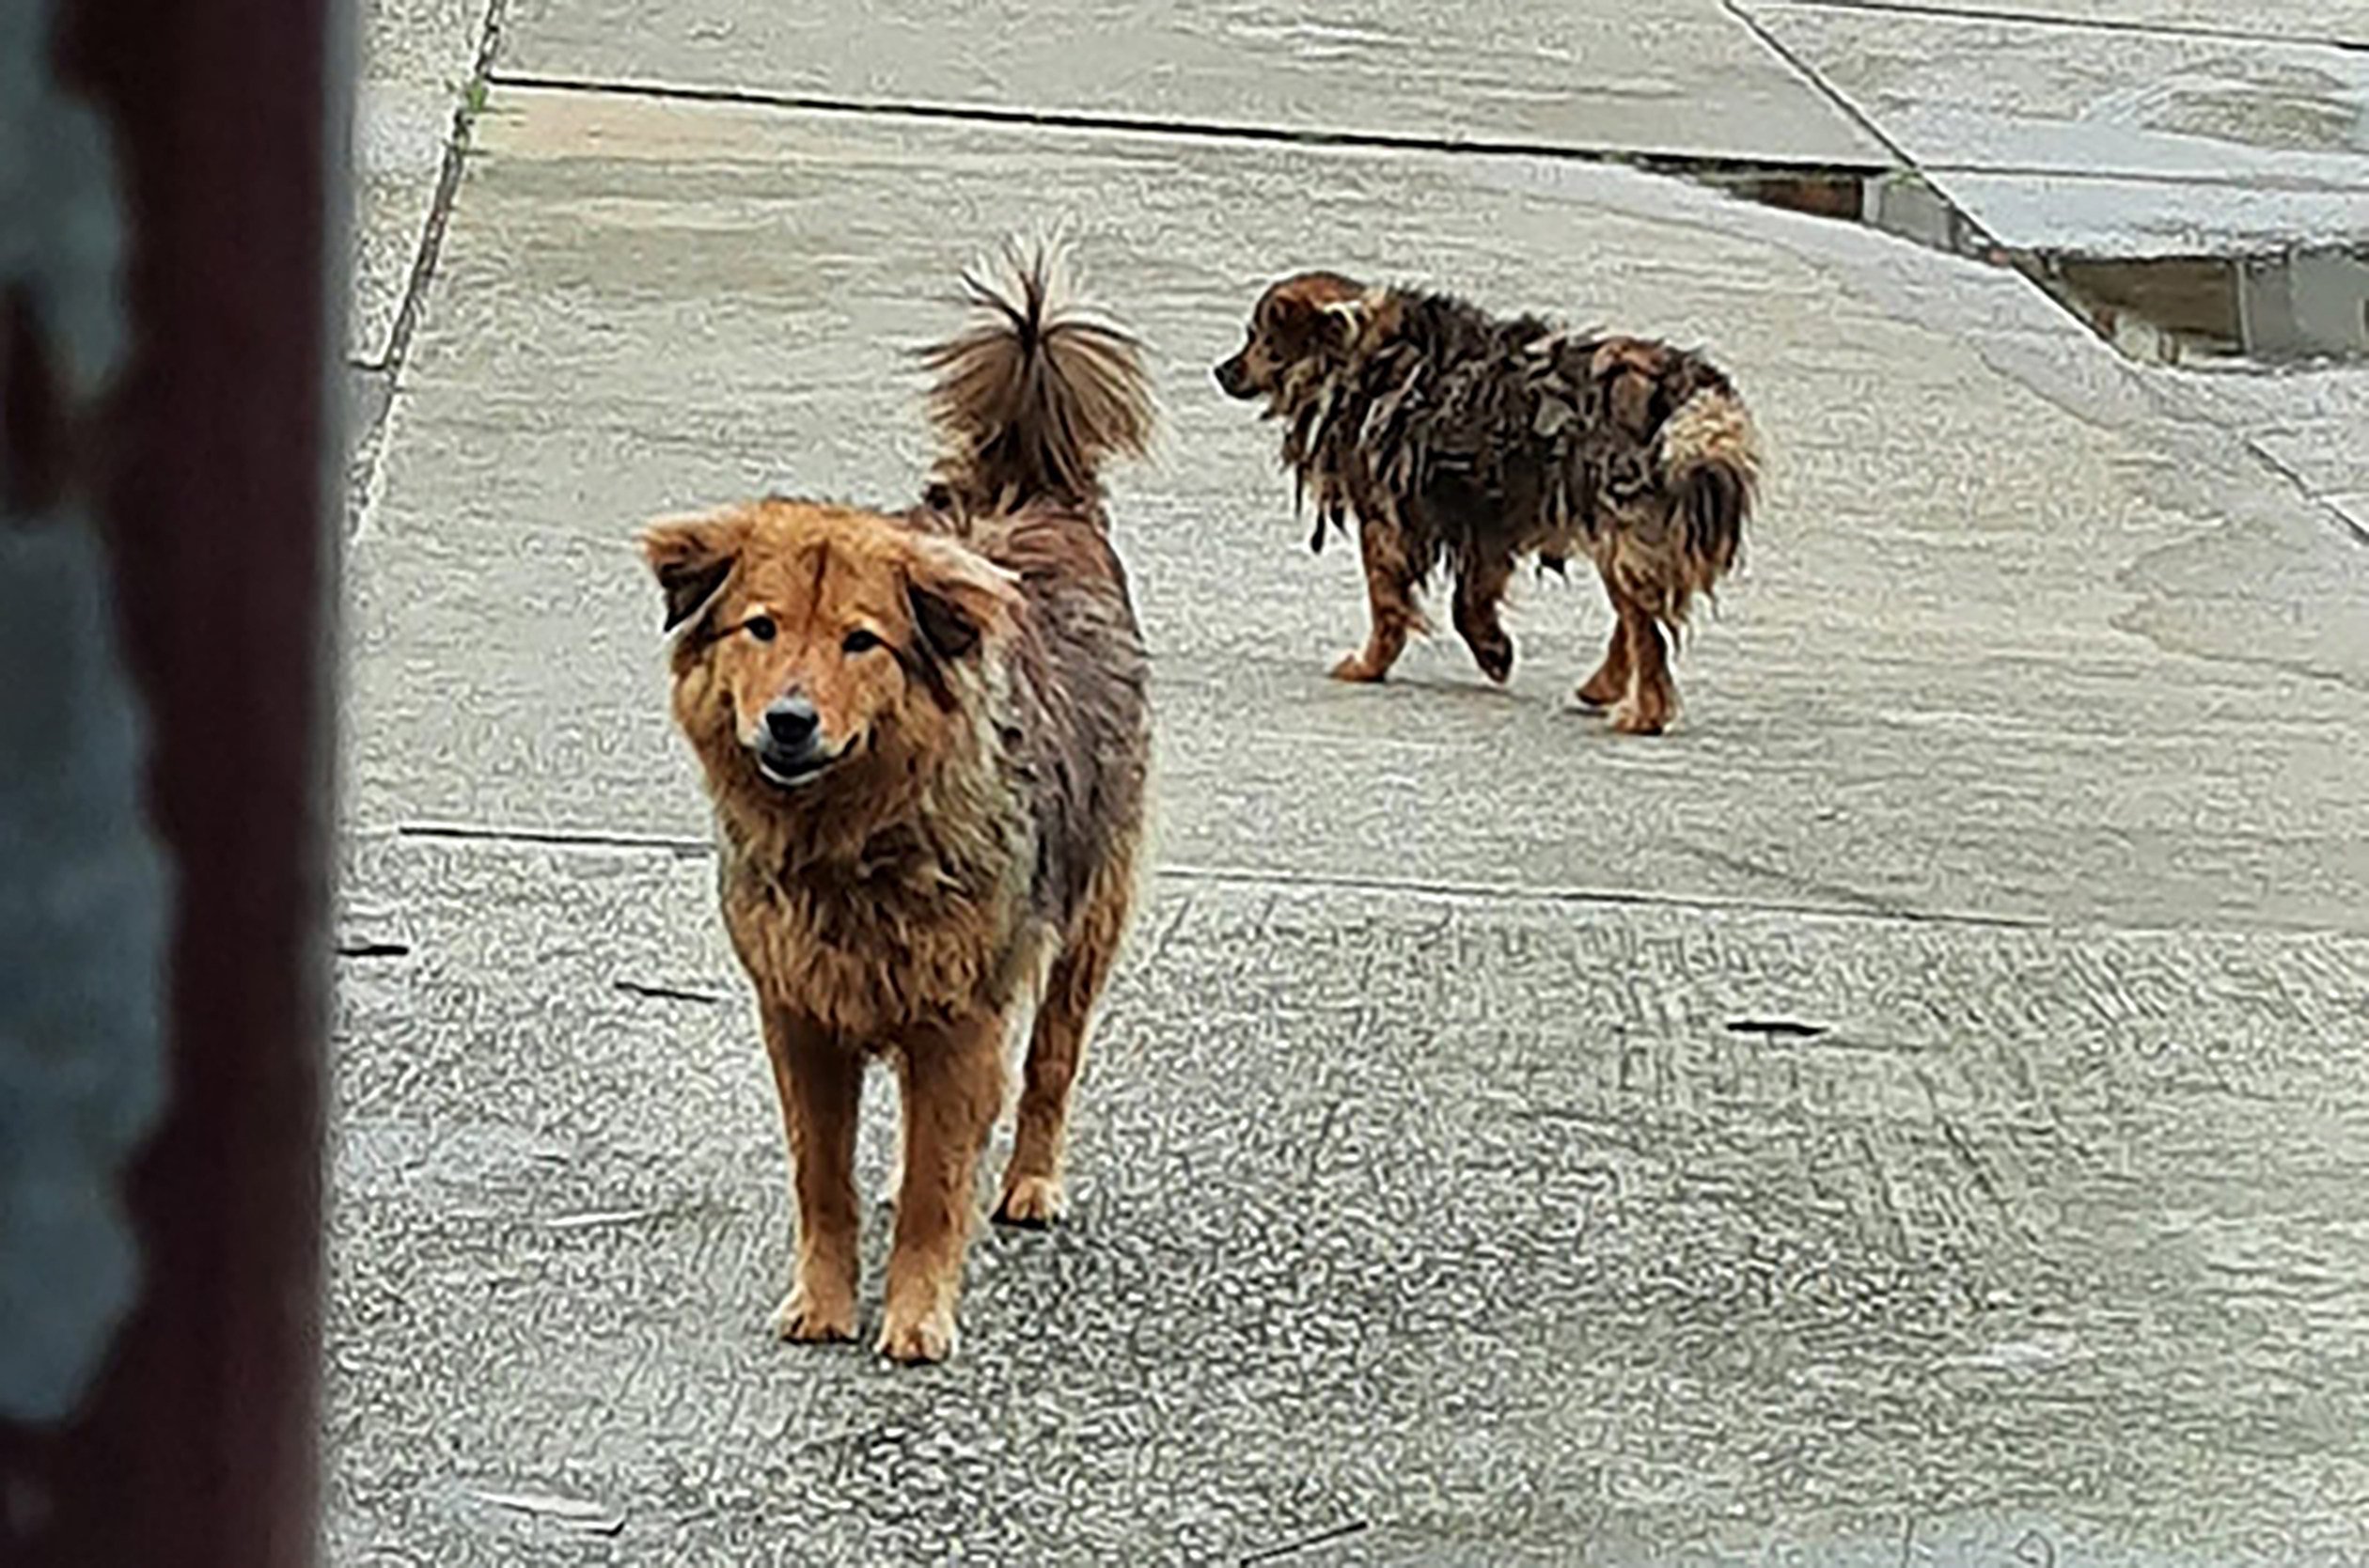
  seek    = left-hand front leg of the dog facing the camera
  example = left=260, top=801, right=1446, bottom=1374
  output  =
left=765, top=1007, right=865, bottom=1341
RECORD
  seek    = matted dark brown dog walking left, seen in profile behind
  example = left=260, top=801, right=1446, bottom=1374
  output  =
left=1216, top=273, right=1760, bottom=734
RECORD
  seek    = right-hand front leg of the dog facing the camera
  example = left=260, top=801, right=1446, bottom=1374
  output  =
left=879, top=1013, right=1004, bottom=1362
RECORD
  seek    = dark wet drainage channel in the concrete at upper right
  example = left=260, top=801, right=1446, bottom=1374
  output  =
left=1677, top=164, right=2369, bottom=369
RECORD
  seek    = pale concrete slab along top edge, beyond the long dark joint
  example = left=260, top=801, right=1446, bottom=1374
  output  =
left=505, top=0, right=1881, bottom=164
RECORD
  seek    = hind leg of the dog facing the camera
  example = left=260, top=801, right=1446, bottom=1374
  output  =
left=995, top=846, right=1135, bottom=1227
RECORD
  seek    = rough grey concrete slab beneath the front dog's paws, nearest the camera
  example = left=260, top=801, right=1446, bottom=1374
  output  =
left=332, top=843, right=2369, bottom=1563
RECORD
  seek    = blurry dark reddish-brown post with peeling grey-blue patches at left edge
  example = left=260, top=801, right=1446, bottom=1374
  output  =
left=0, top=0, right=351, bottom=1568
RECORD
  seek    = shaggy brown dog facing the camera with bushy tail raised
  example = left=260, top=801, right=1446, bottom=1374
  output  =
left=642, top=254, right=1152, bottom=1362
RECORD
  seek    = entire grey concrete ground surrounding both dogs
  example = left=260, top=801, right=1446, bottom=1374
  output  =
left=327, top=0, right=2369, bottom=1565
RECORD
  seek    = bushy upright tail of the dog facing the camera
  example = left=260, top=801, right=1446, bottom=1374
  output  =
left=921, top=244, right=1153, bottom=511
